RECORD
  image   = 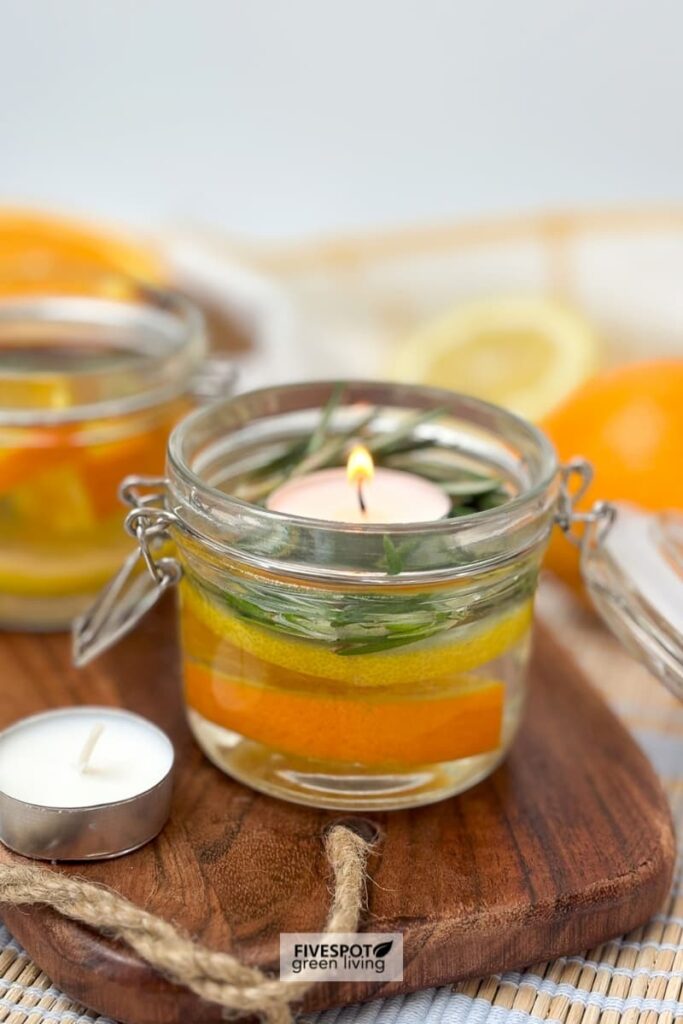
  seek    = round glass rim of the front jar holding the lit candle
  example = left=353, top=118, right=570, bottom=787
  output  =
left=167, top=379, right=559, bottom=537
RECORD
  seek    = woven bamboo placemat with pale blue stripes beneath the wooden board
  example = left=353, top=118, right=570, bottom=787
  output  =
left=0, top=585, right=683, bottom=1024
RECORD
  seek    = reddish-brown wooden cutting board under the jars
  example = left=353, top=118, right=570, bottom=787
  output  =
left=0, top=601, right=674, bottom=1024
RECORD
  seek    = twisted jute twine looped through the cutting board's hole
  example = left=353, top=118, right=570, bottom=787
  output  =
left=0, top=825, right=370, bottom=1024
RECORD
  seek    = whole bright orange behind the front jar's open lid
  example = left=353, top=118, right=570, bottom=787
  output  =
left=542, top=358, right=683, bottom=588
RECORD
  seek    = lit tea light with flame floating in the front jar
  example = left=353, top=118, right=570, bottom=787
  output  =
left=266, top=444, right=451, bottom=523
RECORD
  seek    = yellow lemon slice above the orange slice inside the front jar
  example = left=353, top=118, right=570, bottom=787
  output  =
left=180, top=579, right=532, bottom=686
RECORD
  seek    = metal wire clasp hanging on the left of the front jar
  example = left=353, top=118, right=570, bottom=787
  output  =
left=73, top=476, right=182, bottom=666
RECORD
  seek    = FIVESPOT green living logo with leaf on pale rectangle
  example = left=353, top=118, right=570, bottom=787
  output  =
left=280, top=932, right=403, bottom=981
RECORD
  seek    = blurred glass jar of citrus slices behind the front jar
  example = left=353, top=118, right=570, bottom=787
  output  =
left=0, top=279, right=232, bottom=630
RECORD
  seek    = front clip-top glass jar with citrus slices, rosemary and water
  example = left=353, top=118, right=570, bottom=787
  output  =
left=77, top=382, right=561, bottom=809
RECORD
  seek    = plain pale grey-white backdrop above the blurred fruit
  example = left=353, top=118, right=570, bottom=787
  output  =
left=0, top=0, right=683, bottom=238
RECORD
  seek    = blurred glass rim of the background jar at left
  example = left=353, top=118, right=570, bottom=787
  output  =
left=0, top=279, right=207, bottom=427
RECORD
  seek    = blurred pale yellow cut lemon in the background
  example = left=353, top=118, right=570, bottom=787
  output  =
left=393, top=296, right=600, bottom=420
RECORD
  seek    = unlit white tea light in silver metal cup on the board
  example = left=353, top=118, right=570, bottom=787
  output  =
left=0, top=708, right=174, bottom=860
